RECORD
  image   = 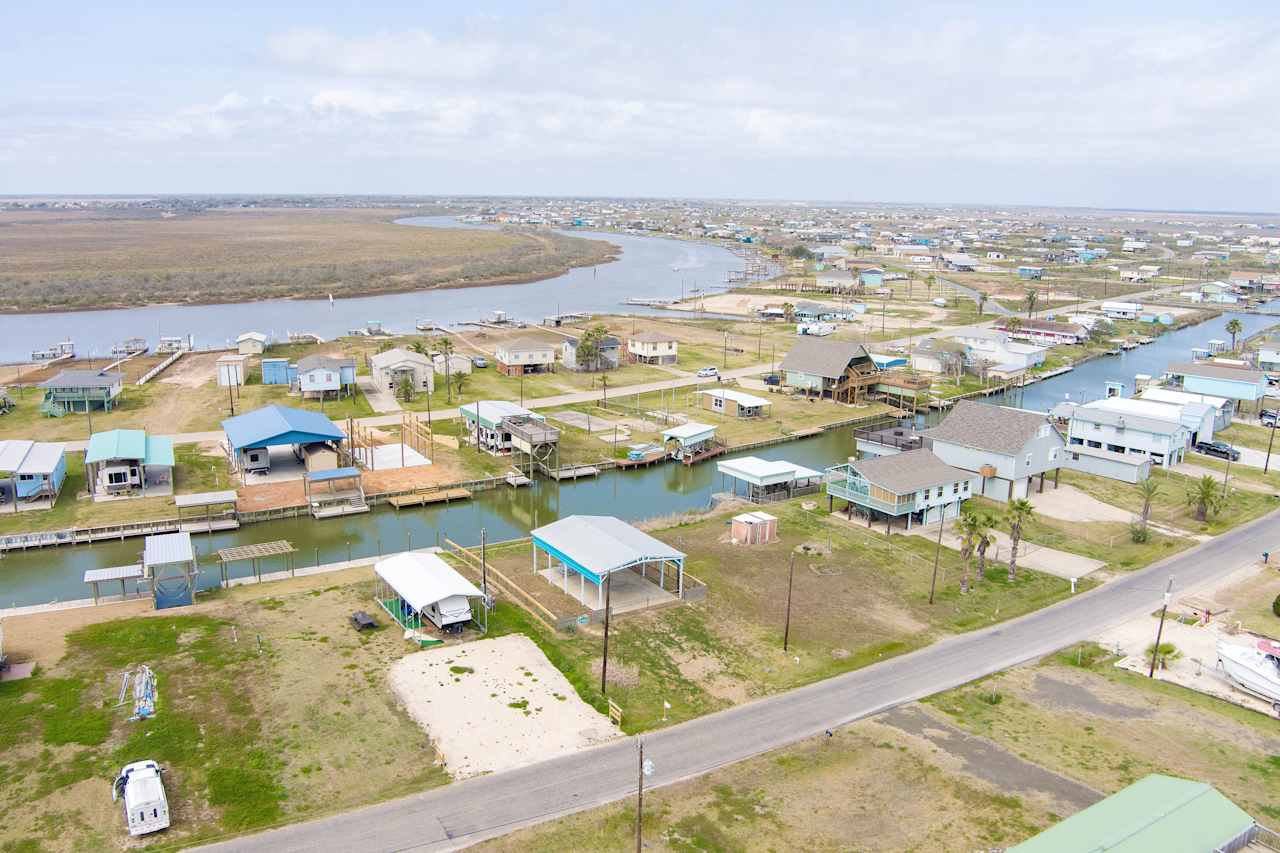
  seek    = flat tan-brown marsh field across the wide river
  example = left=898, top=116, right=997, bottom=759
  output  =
left=0, top=209, right=614, bottom=311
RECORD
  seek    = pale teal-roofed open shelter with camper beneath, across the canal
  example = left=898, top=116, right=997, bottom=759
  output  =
left=84, top=429, right=174, bottom=500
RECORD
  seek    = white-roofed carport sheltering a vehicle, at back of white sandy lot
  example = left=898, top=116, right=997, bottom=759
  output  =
left=374, top=551, right=484, bottom=633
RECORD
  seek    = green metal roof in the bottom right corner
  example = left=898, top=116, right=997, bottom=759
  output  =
left=1009, top=774, right=1253, bottom=853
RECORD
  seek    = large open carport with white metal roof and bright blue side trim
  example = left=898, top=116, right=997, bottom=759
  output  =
left=529, top=515, right=685, bottom=607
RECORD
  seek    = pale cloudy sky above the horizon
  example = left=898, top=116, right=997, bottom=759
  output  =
left=0, top=0, right=1280, bottom=211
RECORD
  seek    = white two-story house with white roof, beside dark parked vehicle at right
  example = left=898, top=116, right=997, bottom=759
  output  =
left=1053, top=397, right=1192, bottom=467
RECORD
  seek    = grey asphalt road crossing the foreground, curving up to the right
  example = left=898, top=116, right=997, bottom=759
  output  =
left=202, top=504, right=1280, bottom=853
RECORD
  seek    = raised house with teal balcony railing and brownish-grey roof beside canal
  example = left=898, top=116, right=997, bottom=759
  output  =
left=824, top=448, right=974, bottom=532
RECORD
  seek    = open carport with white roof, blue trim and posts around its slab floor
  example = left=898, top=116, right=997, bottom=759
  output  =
left=529, top=515, right=685, bottom=612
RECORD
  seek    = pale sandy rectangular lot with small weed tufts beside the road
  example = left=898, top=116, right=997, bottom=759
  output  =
left=390, top=635, right=620, bottom=779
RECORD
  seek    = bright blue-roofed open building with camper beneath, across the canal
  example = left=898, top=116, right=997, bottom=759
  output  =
left=223, top=406, right=347, bottom=474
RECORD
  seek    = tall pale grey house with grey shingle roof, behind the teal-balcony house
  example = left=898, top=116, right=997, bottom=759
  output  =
left=924, top=400, right=1066, bottom=501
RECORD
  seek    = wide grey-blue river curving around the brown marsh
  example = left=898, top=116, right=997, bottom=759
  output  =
left=0, top=216, right=742, bottom=361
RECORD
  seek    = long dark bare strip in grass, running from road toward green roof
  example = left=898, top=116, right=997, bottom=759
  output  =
left=873, top=706, right=1102, bottom=811
